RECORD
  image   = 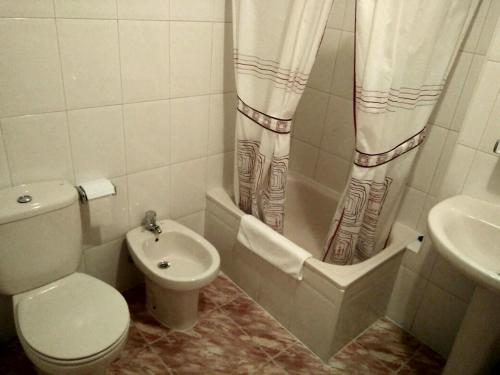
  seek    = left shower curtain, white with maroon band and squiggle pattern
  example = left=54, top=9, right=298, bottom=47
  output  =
left=233, top=0, right=332, bottom=233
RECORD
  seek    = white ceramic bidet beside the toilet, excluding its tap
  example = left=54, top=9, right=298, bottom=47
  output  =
left=127, top=220, right=220, bottom=330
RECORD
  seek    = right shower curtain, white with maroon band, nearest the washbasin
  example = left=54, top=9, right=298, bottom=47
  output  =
left=323, top=0, right=478, bottom=264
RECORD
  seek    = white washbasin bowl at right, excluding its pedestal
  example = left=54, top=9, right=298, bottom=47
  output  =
left=428, top=195, right=500, bottom=293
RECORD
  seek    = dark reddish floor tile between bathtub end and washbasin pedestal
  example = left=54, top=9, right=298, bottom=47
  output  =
left=356, top=319, right=420, bottom=371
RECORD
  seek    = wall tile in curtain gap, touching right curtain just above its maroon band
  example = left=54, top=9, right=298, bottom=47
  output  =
left=321, top=95, right=355, bottom=160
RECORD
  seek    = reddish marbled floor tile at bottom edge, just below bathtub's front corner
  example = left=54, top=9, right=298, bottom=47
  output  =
left=273, top=344, right=332, bottom=375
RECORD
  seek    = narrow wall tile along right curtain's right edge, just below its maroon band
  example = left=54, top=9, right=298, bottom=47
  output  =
left=409, top=125, right=448, bottom=192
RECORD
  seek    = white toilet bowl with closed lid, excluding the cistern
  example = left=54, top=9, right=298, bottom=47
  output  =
left=13, top=273, right=130, bottom=375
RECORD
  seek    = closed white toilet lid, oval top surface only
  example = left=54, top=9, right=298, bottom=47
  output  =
left=16, top=273, right=130, bottom=360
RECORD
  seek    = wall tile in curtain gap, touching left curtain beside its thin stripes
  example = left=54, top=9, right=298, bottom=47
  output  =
left=307, top=29, right=342, bottom=91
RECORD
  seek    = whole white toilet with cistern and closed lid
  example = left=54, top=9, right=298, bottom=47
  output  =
left=0, top=181, right=130, bottom=374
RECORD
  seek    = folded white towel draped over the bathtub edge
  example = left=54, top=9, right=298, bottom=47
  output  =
left=237, top=215, right=312, bottom=280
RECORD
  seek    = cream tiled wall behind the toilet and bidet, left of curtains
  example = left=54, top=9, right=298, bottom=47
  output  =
left=0, top=0, right=234, bottom=340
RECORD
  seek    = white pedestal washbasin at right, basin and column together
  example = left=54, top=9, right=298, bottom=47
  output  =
left=428, top=195, right=500, bottom=375
